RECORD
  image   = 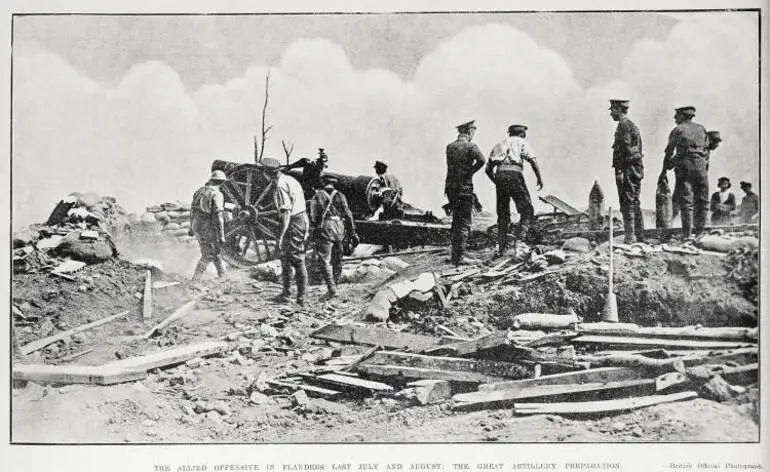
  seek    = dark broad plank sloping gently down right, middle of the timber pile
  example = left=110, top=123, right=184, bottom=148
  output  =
left=366, top=351, right=534, bottom=379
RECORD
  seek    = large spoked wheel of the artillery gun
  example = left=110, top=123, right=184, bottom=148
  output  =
left=222, top=165, right=280, bottom=267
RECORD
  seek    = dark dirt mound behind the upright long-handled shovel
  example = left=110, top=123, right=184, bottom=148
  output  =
left=472, top=252, right=757, bottom=328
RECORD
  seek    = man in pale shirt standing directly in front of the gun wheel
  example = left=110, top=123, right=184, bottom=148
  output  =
left=262, top=158, right=308, bottom=306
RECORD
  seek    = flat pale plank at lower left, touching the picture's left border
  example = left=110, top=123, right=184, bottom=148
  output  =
left=13, top=364, right=147, bottom=385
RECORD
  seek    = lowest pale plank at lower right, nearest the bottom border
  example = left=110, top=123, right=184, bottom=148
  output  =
left=513, top=392, right=698, bottom=415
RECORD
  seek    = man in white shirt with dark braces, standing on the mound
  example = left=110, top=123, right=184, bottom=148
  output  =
left=486, top=125, right=543, bottom=256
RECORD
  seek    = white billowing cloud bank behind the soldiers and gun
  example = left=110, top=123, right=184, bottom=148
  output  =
left=13, top=14, right=759, bottom=232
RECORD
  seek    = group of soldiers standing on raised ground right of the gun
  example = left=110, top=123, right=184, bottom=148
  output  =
left=444, top=99, right=759, bottom=265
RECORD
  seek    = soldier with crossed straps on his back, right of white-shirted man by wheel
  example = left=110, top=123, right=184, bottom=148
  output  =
left=310, top=175, right=358, bottom=299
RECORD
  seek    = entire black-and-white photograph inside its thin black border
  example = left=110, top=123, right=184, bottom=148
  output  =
left=9, top=9, right=761, bottom=444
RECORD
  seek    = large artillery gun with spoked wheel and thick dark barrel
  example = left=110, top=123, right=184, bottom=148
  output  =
left=211, top=149, right=450, bottom=267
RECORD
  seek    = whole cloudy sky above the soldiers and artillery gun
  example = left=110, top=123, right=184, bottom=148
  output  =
left=12, top=11, right=759, bottom=229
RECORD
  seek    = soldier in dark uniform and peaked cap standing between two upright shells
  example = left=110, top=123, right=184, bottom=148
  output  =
left=610, top=99, right=644, bottom=244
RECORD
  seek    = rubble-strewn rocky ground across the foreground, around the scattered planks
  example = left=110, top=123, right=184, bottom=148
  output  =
left=12, top=230, right=759, bottom=443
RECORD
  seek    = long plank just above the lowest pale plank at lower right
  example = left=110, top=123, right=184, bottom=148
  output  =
left=452, top=374, right=664, bottom=411
